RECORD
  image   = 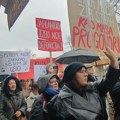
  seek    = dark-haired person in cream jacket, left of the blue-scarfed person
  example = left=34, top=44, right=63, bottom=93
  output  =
left=26, top=83, right=39, bottom=118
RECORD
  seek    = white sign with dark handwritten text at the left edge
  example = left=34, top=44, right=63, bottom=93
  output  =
left=0, top=51, right=30, bottom=74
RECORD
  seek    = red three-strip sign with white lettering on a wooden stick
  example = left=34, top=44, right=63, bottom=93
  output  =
left=36, top=18, right=63, bottom=51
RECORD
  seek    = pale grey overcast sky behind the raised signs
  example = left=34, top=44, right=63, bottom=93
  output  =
left=0, top=0, right=70, bottom=57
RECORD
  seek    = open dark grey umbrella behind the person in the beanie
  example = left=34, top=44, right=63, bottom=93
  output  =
left=55, top=49, right=100, bottom=64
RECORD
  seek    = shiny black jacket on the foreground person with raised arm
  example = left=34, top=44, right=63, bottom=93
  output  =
left=47, top=67, right=120, bottom=120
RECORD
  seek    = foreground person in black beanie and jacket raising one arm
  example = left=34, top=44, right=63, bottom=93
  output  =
left=47, top=48, right=120, bottom=120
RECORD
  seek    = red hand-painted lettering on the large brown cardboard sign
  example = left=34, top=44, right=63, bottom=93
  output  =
left=72, top=17, right=120, bottom=53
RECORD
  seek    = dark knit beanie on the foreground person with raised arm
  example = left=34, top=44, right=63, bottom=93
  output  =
left=62, top=62, right=86, bottom=83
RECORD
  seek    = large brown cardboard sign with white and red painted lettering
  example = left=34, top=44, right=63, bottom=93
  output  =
left=67, top=0, right=120, bottom=54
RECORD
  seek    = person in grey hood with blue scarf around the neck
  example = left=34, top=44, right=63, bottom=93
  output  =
left=30, top=74, right=60, bottom=120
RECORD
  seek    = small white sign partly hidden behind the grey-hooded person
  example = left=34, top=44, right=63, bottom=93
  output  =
left=34, top=65, right=46, bottom=81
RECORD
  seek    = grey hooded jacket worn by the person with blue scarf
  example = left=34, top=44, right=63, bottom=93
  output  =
left=30, top=74, right=60, bottom=120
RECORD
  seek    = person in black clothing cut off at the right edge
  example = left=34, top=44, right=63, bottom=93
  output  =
left=110, top=58, right=120, bottom=120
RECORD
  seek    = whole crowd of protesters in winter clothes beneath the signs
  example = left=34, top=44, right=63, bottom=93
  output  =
left=0, top=47, right=120, bottom=120
